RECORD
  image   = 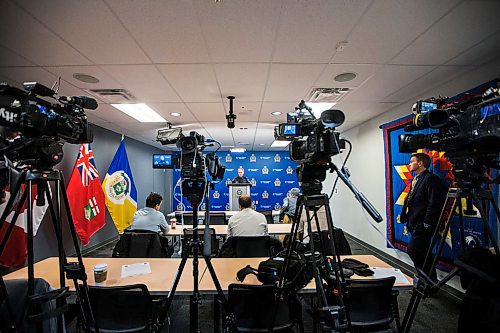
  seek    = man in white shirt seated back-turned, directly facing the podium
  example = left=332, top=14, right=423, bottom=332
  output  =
left=227, top=194, right=268, bottom=237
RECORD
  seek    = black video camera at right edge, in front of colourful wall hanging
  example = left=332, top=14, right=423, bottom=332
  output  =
left=398, top=79, right=500, bottom=182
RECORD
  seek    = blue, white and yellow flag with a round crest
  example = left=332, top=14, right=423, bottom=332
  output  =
left=102, top=139, right=137, bottom=233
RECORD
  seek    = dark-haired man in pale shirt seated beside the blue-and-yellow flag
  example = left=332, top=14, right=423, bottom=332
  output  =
left=130, top=192, right=170, bottom=234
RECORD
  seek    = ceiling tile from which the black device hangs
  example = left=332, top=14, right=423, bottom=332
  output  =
left=215, top=64, right=268, bottom=102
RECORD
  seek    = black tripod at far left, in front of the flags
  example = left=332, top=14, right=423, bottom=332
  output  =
left=0, top=170, right=99, bottom=332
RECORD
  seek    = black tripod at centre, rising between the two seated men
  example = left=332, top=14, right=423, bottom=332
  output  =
left=166, top=179, right=229, bottom=333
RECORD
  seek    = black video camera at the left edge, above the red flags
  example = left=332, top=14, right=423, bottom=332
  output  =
left=0, top=82, right=97, bottom=169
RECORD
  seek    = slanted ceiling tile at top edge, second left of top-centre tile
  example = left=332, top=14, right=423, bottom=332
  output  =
left=16, top=0, right=151, bottom=64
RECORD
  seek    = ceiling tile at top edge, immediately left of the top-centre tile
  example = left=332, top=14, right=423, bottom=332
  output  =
left=106, top=0, right=209, bottom=63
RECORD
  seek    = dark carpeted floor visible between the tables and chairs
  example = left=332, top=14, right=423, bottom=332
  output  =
left=81, top=233, right=461, bottom=333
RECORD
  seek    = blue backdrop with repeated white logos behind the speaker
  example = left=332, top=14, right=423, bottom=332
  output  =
left=172, top=151, right=299, bottom=211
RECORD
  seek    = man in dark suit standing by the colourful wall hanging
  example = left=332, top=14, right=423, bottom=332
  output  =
left=400, top=153, right=446, bottom=281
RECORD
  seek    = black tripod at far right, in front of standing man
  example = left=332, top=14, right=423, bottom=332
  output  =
left=401, top=183, right=500, bottom=332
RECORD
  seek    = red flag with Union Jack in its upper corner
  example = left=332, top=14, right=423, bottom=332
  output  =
left=67, top=143, right=106, bottom=245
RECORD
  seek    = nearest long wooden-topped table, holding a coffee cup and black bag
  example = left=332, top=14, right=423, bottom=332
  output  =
left=3, top=255, right=413, bottom=295
